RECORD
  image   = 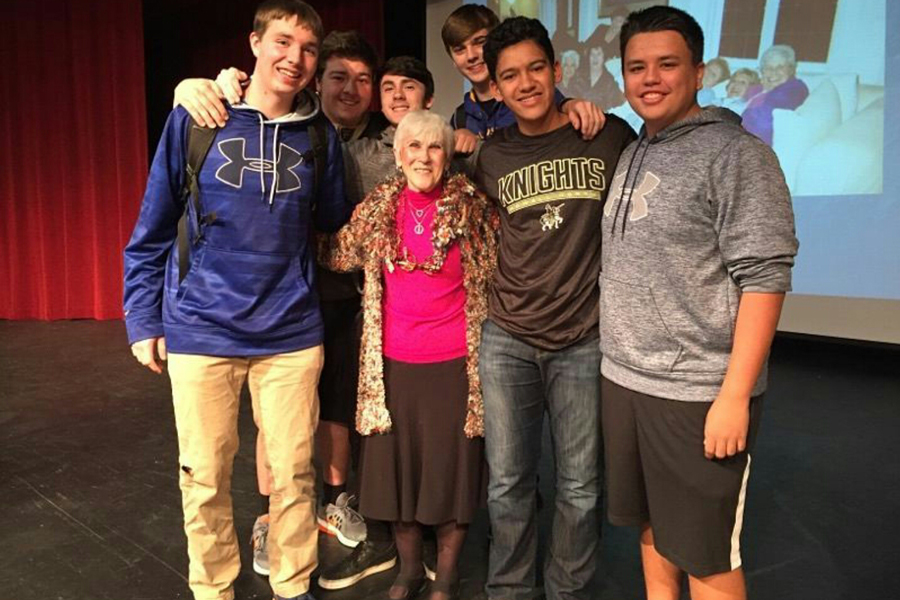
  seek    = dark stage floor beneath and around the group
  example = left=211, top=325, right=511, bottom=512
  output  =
left=0, top=321, right=900, bottom=600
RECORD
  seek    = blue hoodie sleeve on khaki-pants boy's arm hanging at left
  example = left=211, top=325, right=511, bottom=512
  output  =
left=125, top=107, right=191, bottom=344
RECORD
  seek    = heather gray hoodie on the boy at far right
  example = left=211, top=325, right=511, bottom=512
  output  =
left=600, top=107, right=798, bottom=402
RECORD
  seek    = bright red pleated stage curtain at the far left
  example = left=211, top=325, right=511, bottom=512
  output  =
left=0, top=0, right=147, bottom=319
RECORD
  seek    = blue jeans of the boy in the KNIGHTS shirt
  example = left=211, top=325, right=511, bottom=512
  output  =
left=479, top=321, right=603, bottom=600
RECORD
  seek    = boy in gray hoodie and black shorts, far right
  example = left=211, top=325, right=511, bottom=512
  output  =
left=601, top=6, right=797, bottom=600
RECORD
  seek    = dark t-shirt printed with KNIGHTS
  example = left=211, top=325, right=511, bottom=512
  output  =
left=476, top=115, right=636, bottom=350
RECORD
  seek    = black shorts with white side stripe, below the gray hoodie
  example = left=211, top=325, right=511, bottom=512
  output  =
left=602, top=378, right=763, bottom=577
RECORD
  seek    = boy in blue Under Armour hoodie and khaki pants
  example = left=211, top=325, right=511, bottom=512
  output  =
left=119, top=0, right=351, bottom=600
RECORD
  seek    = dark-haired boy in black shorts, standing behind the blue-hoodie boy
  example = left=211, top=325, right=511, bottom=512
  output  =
left=175, top=31, right=391, bottom=575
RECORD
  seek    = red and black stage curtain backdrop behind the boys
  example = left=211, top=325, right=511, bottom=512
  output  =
left=0, top=0, right=383, bottom=319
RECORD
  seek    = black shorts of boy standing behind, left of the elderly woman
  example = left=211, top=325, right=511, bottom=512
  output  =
left=319, top=297, right=362, bottom=430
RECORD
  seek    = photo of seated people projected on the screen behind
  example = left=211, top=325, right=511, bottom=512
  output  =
left=486, top=0, right=885, bottom=196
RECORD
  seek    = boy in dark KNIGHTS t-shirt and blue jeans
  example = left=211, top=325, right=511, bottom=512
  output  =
left=476, top=17, right=635, bottom=600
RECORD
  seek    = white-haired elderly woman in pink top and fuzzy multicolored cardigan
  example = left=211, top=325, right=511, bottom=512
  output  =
left=320, top=111, right=498, bottom=600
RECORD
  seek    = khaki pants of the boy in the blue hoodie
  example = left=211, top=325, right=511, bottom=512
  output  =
left=169, top=346, right=322, bottom=600
